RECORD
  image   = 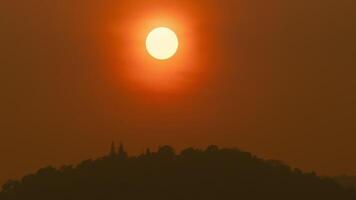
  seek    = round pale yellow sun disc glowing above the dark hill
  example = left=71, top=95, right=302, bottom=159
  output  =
left=146, top=27, right=179, bottom=60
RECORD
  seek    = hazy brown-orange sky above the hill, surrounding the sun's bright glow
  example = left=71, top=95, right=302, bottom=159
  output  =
left=0, top=0, right=356, bottom=183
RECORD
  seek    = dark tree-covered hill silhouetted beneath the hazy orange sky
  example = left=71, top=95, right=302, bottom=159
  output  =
left=0, top=146, right=356, bottom=200
